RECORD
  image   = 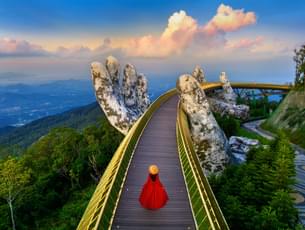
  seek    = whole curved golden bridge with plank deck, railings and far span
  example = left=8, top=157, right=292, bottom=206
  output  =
left=78, top=83, right=291, bottom=230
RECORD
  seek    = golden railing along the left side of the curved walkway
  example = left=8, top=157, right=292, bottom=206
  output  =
left=77, top=89, right=176, bottom=230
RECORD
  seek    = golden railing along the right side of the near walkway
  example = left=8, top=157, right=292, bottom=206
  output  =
left=176, top=103, right=229, bottom=230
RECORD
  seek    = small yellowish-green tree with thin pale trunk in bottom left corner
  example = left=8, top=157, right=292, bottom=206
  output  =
left=0, top=157, right=31, bottom=230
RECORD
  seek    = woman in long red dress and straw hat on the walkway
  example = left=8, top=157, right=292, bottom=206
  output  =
left=139, top=165, right=168, bottom=209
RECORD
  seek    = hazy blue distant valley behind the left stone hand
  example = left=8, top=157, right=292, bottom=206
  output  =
left=0, top=78, right=175, bottom=128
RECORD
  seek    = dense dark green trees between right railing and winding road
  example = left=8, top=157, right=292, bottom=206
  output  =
left=209, top=129, right=300, bottom=230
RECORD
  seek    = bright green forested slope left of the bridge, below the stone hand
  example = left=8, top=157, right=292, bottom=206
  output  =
left=0, top=117, right=122, bottom=230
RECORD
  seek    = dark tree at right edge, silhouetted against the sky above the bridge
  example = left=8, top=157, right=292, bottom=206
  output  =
left=293, top=44, right=305, bottom=87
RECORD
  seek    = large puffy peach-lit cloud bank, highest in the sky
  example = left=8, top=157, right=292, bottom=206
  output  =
left=125, top=4, right=256, bottom=58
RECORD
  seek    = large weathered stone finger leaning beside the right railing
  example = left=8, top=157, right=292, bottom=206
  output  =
left=176, top=74, right=230, bottom=175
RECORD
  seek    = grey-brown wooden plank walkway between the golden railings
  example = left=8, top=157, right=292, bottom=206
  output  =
left=112, top=96, right=195, bottom=230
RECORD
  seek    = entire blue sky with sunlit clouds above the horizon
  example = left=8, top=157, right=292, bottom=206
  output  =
left=0, top=0, right=305, bottom=85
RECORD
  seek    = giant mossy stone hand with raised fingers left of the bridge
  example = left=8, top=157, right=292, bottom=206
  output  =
left=91, top=56, right=150, bottom=135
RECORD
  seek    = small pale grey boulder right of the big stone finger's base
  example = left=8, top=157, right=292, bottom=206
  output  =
left=229, top=136, right=260, bottom=163
